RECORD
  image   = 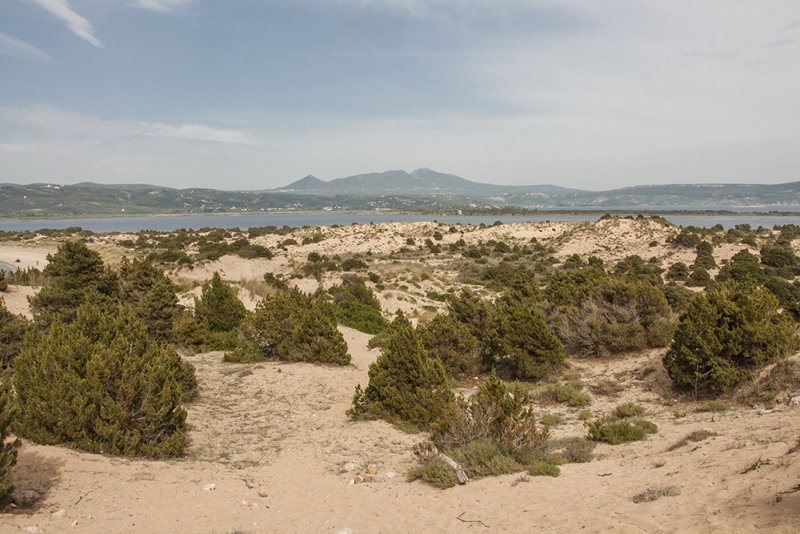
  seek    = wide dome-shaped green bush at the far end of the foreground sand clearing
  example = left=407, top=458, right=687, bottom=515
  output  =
left=225, top=290, right=350, bottom=365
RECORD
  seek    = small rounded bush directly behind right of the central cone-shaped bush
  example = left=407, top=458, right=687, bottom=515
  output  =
left=417, top=315, right=481, bottom=379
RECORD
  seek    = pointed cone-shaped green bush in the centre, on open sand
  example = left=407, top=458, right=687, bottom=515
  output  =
left=348, top=316, right=455, bottom=429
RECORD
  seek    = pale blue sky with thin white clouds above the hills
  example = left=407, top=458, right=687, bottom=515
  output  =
left=0, top=0, right=800, bottom=190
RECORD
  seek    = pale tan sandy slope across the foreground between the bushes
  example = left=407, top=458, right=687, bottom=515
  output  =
left=0, top=328, right=800, bottom=533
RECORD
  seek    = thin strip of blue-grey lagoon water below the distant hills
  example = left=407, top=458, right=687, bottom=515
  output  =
left=0, top=207, right=800, bottom=232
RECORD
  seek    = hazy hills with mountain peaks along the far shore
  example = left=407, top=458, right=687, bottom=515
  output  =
left=0, top=173, right=800, bottom=221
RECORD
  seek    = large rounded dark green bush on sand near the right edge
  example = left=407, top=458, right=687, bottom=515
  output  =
left=663, top=282, right=796, bottom=392
